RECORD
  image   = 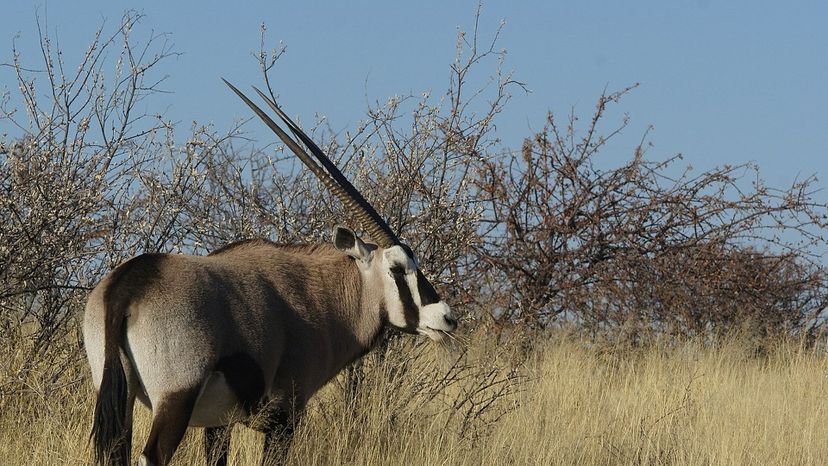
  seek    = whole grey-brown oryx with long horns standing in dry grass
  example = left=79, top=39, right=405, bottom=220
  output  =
left=83, top=81, right=457, bottom=465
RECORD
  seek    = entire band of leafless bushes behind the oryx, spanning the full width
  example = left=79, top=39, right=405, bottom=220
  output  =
left=0, top=8, right=828, bottom=368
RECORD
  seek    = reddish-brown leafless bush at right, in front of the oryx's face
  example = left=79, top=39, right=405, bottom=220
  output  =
left=477, top=89, right=828, bottom=340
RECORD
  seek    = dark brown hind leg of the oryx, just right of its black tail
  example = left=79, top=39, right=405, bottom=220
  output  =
left=138, top=387, right=199, bottom=466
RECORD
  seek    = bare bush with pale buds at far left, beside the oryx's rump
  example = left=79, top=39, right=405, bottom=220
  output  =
left=0, top=14, right=176, bottom=354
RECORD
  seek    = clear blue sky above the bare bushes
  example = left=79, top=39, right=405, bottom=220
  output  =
left=0, top=0, right=828, bottom=195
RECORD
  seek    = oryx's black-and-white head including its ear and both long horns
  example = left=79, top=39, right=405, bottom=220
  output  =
left=224, top=80, right=457, bottom=340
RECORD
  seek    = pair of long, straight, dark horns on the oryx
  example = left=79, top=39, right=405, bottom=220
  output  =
left=222, top=78, right=399, bottom=247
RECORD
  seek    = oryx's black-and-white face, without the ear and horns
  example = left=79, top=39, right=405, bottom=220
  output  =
left=382, top=245, right=457, bottom=340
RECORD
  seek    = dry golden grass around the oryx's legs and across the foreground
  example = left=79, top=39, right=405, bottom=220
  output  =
left=0, top=334, right=828, bottom=465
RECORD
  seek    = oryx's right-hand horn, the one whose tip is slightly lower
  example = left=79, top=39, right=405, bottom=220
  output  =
left=253, top=86, right=399, bottom=248
